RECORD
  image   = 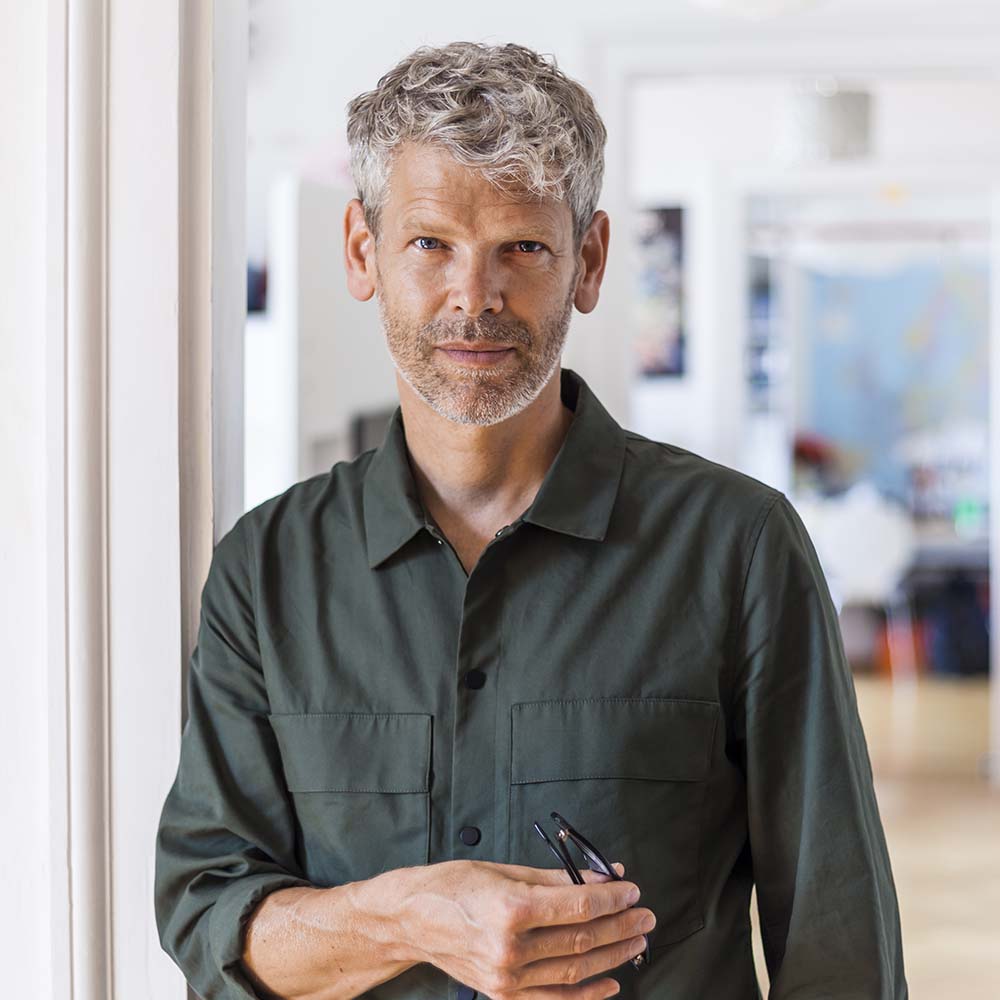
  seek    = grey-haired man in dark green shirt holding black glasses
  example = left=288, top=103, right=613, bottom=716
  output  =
left=156, top=43, right=906, bottom=1000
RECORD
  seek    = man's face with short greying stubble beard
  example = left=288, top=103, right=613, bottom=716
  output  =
left=375, top=145, right=580, bottom=426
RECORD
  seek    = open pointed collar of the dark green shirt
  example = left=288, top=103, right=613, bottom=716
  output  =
left=363, top=368, right=625, bottom=569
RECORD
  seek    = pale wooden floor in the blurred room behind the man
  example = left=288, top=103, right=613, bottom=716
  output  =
left=752, top=676, right=1000, bottom=1000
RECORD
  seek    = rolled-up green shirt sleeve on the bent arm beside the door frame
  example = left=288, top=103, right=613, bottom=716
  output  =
left=154, top=522, right=310, bottom=1000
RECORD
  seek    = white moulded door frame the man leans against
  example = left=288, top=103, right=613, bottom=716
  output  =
left=45, top=0, right=248, bottom=1000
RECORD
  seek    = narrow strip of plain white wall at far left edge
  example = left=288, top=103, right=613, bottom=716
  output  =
left=0, top=3, right=52, bottom=998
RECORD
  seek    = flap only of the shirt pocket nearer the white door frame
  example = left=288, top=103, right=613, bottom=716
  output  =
left=268, top=712, right=431, bottom=792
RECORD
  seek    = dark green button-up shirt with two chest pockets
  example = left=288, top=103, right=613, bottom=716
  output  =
left=155, top=369, right=907, bottom=1000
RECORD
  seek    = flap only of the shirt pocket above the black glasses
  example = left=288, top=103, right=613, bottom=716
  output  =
left=511, top=698, right=719, bottom=784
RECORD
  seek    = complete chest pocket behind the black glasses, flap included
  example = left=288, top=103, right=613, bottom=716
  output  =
left=508, top=698, right=719, bottom=948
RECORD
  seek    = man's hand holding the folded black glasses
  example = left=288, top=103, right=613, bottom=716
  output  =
left=394, top=861, right=656, bottom=1000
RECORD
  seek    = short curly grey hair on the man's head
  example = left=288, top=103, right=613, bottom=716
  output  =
left=347, top=42, right=607, bottom=251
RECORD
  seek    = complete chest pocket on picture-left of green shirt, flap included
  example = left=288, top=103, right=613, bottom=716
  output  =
left=268, top=712, right=432, bottom=885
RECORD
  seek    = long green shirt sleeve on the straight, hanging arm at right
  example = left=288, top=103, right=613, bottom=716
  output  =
left=734, top=493, right=907, bottom=1000
